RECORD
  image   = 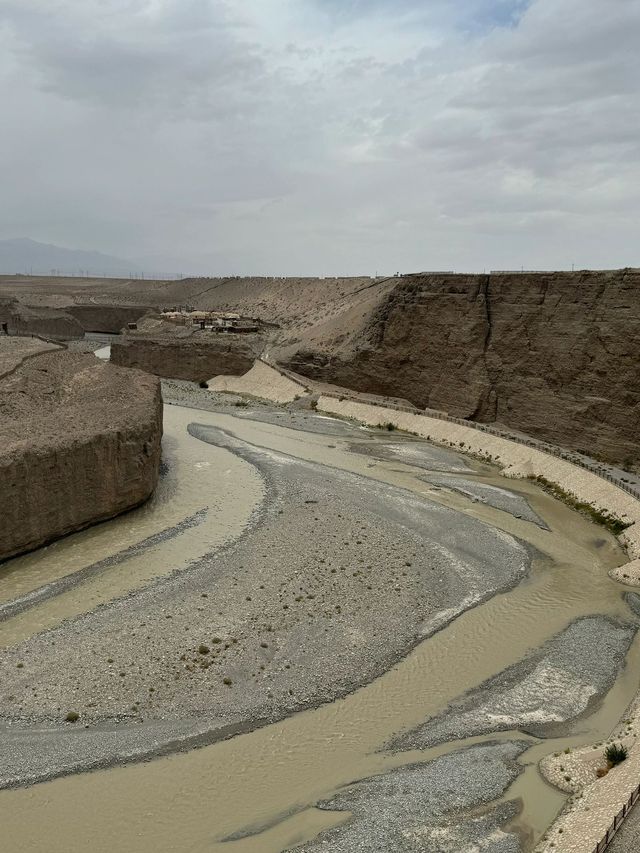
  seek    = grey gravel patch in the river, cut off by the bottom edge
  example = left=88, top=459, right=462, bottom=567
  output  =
left=296, top=742, right=529, bottom=853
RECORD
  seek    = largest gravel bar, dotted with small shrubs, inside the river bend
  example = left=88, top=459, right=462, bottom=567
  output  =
left=0, top=426, right=530, bottom=784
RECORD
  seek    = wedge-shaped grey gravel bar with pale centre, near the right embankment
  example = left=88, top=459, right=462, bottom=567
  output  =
left=391, top=616, right=636, bottom=750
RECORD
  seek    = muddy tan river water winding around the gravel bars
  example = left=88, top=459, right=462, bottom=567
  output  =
left=0, top=406, right=640, bottom=853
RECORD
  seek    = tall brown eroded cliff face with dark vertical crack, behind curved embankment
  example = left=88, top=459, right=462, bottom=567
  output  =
left=283, top=270, right=640, bottom=465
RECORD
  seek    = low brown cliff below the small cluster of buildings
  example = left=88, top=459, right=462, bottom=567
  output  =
left=111, top=332, right=263, bottom=382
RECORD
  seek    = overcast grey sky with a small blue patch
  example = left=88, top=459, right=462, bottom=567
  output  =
left=0, top=0, right=640, bottom=275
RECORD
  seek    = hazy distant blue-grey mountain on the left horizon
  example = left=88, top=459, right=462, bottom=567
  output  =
left=0, top=237, right=141, bottom=278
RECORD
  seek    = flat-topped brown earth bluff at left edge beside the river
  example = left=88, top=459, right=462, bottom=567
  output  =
left=0, top=341, right=162, bottom=560
